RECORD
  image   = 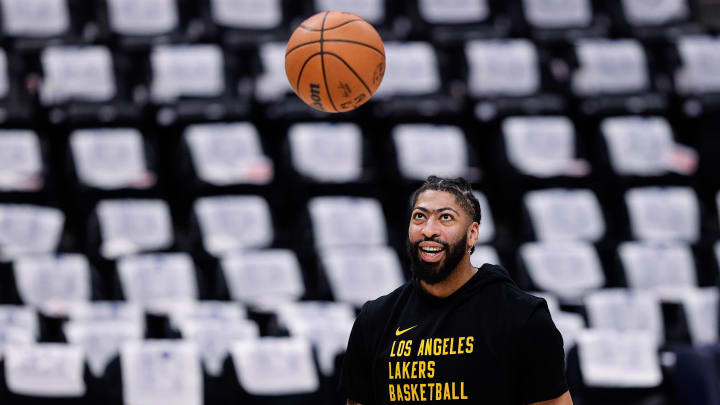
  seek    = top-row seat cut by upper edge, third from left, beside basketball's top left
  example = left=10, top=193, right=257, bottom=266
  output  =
left=208, top=0, right=287, bottom=47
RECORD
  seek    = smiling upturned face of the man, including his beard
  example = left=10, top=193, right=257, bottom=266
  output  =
left=407, top=190, right=476, bottom=285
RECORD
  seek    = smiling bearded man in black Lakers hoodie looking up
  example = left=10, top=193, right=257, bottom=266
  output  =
left=341, top=176, right=572, bottom=405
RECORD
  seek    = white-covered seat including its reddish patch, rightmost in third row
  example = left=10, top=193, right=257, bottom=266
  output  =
left=600, top=116, right=698, bottom=181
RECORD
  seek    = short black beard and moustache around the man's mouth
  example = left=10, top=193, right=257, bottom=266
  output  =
left=407, top=235, right=467, bottom=285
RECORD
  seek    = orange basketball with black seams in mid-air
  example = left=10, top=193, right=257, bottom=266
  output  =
left=285, top=11, right=385, bottom=113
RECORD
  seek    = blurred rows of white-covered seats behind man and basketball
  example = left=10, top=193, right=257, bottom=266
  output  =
left=0, top=0, right=720, bottom=405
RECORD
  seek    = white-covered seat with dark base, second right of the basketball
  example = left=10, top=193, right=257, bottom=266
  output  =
left=465, top=39, right=565, bottom=121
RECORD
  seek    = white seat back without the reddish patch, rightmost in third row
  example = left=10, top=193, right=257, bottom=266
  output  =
left=600, top=117, right=675, bottom=176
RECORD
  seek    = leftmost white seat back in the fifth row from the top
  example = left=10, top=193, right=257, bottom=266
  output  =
left=13, top=254, right=91, bottom=309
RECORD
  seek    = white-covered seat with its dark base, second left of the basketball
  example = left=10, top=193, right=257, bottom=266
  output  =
left=149, top=44, right=249, bottom=125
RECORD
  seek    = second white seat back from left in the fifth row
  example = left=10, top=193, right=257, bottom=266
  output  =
left=117, top=253, right=198, bottom=305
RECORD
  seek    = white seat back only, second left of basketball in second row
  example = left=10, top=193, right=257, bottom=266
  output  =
left=150, top=44, right=225, bottom=102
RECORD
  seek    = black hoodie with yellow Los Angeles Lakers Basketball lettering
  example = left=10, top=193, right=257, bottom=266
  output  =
left=341, top=264, right=567, bottom=405
